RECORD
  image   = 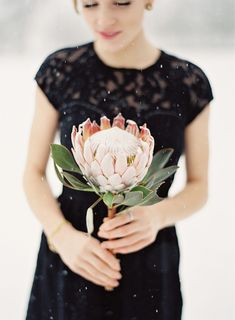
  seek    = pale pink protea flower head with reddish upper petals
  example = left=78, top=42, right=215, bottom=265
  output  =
left=71, top=113, right=154, bottom=193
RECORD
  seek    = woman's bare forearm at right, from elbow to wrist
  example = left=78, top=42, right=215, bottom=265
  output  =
left=152, top=181, right=207, bottom=229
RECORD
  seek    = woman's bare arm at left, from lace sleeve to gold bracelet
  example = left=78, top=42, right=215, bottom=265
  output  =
left=23, top=86, right=71, bottom=236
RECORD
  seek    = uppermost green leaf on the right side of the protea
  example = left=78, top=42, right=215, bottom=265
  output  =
left=141, top=148, right=174, bottom=184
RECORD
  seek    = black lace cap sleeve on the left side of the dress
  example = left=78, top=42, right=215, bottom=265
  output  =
left=34, top=49, right=69, bottom=110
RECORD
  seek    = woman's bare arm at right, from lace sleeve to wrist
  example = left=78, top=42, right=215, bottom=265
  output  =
left=151, top=104, right=209, bottom=228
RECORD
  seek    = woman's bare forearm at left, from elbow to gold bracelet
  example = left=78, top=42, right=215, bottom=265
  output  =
left=23, top=171, right=71, bottom=236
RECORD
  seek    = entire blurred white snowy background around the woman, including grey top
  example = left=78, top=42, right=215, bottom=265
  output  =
left=0, top=0, right=235, bottom=320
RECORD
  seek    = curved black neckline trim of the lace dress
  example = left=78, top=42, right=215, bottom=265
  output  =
left=89, top=41, right=165, bottom=72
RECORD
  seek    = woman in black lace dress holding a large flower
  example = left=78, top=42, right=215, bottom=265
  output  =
left=24, top=0, right=213, bottom=320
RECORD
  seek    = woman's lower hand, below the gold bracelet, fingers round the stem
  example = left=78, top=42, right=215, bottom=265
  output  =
left=53, top=225, right=121, bottom=287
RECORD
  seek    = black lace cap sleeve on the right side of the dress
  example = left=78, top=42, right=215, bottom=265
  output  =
left=184, top=63, right=214, bottom=126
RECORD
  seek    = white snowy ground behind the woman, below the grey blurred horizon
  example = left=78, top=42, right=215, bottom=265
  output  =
left=0, top=48, right=235, bottom=320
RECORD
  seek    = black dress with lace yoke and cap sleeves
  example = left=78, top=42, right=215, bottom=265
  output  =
left=26, top=42, right=213, bottom=320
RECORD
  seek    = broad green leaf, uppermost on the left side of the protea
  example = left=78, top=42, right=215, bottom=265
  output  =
left=51, top=143, right=82, bottom=174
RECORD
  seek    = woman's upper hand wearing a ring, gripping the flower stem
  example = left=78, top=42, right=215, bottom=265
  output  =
left=98, top=206, right=162, bottom=253
